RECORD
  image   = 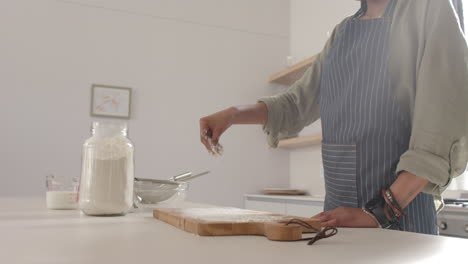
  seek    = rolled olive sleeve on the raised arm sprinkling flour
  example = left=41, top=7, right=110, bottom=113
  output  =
left=258, top=21, right=344, bottom=147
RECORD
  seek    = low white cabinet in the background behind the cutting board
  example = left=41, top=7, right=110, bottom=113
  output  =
left=244, top=194, right=323, bottom=217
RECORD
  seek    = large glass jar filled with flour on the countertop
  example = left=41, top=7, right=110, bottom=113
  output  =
left=79, top=122, right=134, bottom=215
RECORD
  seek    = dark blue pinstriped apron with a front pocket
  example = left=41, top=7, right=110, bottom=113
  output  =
left=320, top=0, right=438, bottom=234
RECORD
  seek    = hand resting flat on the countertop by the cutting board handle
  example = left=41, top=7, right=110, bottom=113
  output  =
left=313, top=207, right=378, bottom=227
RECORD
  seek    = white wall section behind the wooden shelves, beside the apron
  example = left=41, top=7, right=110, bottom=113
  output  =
left=289, top=0, right=360, bottom=195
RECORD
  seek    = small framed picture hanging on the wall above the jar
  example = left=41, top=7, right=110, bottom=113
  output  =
left=91, top=84, right=132, bottom=119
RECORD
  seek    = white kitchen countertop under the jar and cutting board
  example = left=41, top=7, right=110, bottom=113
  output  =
left=0, top=198, right=468, bottom=264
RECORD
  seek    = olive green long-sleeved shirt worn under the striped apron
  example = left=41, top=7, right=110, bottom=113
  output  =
left=259, top=0, right=468, bottom=200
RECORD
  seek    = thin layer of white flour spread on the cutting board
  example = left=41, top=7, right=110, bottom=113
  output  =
left=173, top=208, right=290, bottom=223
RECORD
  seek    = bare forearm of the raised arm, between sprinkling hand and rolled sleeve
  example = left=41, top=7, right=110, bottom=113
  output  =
left=230, top=103, right=268, bottom=125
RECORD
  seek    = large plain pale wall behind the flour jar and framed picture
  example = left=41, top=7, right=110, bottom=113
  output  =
left=0, top=0, right=289, bottom=206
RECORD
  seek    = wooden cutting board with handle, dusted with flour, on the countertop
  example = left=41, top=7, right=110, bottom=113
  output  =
left=153, top=207, right=320, bottom=241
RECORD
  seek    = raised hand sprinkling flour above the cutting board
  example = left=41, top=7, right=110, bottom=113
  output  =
left=200, top=107, right=237, bottom=153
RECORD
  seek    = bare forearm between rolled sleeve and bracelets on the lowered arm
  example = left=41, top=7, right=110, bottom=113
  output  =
left=390, top=171, right=429, bottom=208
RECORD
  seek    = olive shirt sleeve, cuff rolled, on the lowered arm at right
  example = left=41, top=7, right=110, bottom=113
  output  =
left=397, top=1, right=468, bottom=195
